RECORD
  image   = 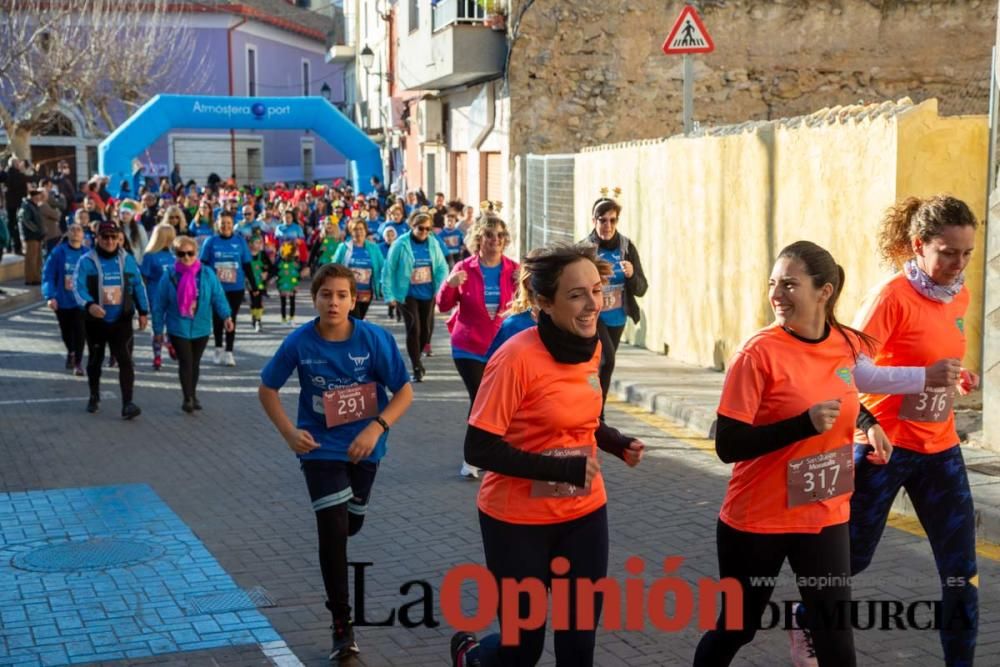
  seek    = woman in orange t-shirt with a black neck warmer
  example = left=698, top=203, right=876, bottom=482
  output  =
left=451, top=246, right=644, bottom=667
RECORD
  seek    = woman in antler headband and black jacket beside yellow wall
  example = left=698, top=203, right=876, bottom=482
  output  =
left=587, top=188, right=649, bottom=412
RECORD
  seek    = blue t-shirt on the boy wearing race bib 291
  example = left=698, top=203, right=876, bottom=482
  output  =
left=260, top=317, right=410, bottom=462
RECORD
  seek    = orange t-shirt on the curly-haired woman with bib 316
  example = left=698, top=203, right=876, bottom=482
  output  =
left=855, top=273, right=969, bottom=454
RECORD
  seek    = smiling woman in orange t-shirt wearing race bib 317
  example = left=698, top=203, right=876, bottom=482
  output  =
left=694, top=241, right=891, bottom=667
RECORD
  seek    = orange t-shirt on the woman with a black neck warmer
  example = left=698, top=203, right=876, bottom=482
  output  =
left=469, top=327, right=607, bottom=524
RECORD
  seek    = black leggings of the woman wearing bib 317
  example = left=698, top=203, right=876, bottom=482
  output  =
left=694, top=519, right=856, bottom=667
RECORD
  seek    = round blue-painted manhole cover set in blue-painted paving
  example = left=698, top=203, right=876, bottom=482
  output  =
left=11, top=537, right=166, bottom=572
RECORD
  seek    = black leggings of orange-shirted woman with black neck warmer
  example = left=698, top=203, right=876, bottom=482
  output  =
left=478, top=507, right=608, bottom=667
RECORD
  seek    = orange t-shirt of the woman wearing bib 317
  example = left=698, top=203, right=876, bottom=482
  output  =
left=719, top=324, right=859, bottom=533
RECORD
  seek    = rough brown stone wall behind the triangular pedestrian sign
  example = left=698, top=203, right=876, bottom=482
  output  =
left=510, top=0, right=997, bottom=155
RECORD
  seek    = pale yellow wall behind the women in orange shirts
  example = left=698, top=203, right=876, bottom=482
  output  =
left=575, top=100, right=987, bottom=368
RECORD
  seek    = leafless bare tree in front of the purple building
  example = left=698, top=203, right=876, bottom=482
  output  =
left=0, top=0, right=206, bottom=159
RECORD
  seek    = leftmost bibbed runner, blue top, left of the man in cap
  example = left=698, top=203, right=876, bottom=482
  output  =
left=42, top=223, right=88, bottom=376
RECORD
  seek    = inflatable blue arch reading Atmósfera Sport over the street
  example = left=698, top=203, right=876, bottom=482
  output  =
left=98, top=95, right=384, bottom=194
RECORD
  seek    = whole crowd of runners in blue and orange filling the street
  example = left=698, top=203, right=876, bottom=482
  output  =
left=9, top=167, right=979, bottom=667
